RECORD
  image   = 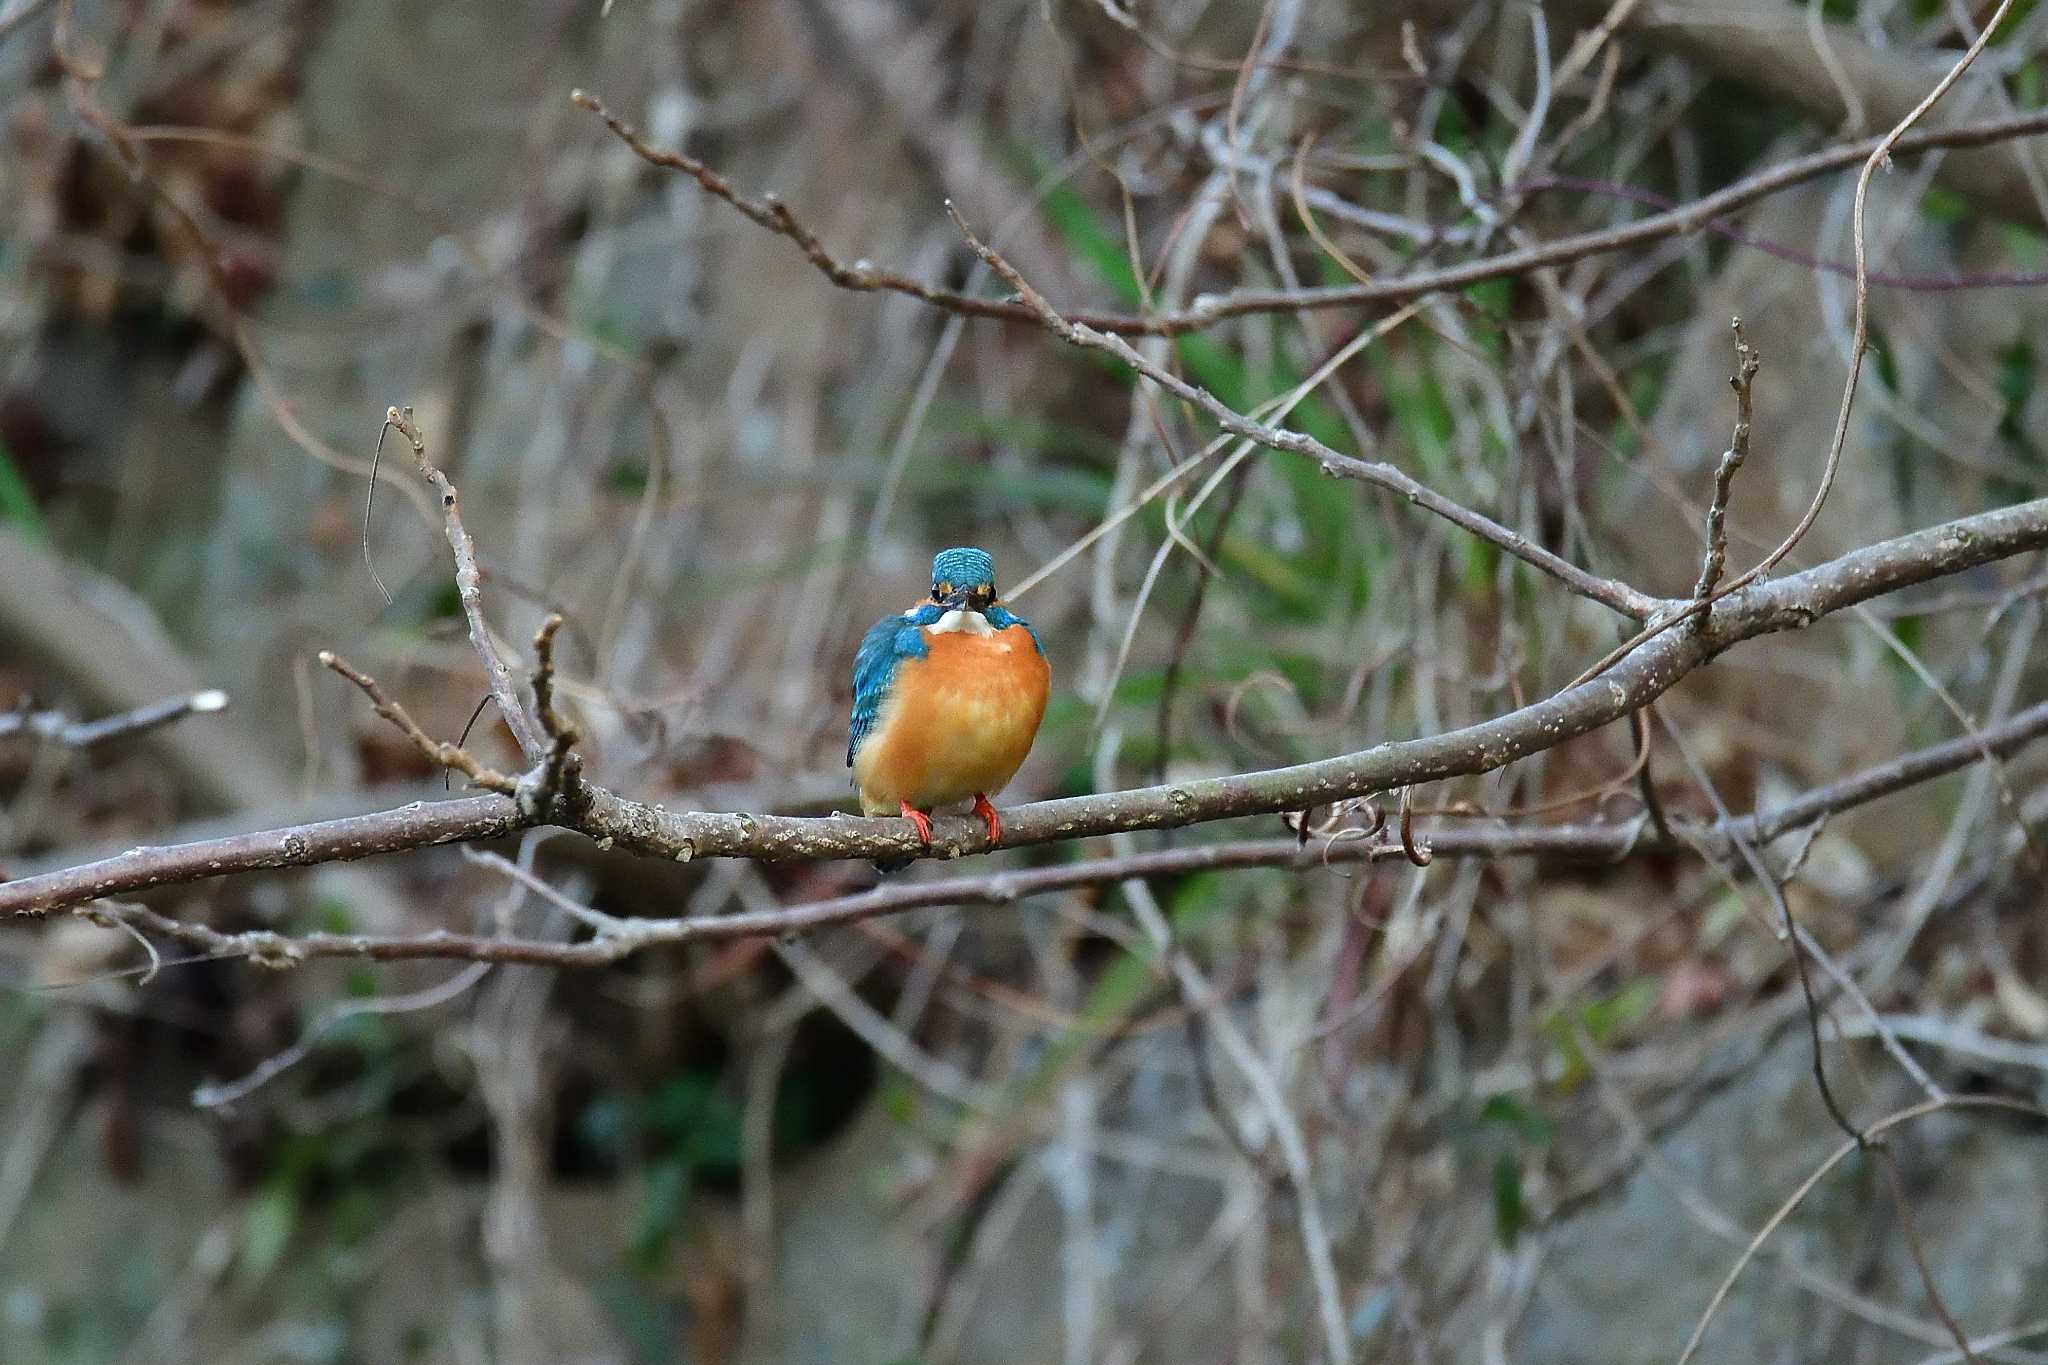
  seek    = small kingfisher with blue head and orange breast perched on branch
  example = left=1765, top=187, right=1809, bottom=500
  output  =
left=846, top=546, right=1053, bottom=845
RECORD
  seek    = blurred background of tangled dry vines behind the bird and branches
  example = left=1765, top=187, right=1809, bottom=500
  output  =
left=0, top=0, right=2048, bottom=1365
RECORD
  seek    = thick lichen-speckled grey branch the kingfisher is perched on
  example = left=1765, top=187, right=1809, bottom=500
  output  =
left=0, top=499, right=2048, bottom=913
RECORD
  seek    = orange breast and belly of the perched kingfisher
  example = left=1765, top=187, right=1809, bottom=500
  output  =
left=854, top=626, right=1053, bottom=814
